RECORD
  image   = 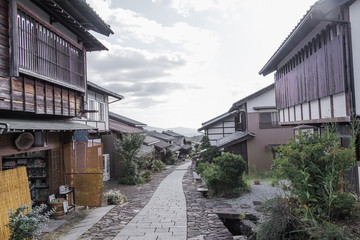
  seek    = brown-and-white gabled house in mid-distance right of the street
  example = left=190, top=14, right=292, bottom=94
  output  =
left=198, top=84, right=293, bottom=171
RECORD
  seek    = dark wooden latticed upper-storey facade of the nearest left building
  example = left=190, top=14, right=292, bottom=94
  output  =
left=0, top=1, right=85, bottom=117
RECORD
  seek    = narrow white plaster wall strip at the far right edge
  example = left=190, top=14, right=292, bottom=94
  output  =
left=350, top=1, right=360, bottom=115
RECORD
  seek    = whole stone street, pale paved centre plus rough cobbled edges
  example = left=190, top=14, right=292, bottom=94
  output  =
left=40, top=161, right=232, bottom=240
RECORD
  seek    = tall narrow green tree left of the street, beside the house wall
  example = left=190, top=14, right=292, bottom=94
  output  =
left=115, top=134, right=145, bottom=185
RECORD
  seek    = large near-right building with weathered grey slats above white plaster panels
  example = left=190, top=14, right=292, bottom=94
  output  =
left=260, top=0, right=360, bottom=191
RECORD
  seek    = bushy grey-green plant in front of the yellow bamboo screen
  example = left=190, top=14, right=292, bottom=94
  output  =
left=7, top=204, right=55, bottom=240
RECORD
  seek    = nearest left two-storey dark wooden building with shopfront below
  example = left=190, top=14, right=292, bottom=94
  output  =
left=0, top=0, right=113, bottom=206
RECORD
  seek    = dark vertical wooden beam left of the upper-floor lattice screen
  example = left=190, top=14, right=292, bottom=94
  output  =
left=9, top=0, right=19, bottom=77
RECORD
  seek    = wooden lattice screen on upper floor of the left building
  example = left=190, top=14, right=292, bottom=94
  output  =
left=17, top=8, right=85, bottom=89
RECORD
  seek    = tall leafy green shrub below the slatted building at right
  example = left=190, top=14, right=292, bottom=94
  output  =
left=273, top=127, right=355, bottom=221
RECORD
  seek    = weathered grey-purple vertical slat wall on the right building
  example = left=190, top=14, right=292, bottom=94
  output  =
left=275, top=24, right=345, bottom=109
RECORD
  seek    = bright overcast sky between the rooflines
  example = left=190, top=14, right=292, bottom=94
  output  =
left=87, top=0, right=315, bottom=128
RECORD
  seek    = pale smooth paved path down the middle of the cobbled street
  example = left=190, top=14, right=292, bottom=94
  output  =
left=114, top=162, right=191, bottom=240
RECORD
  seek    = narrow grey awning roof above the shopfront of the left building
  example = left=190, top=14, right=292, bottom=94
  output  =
left=0, top=118, right=97, bottom=133
